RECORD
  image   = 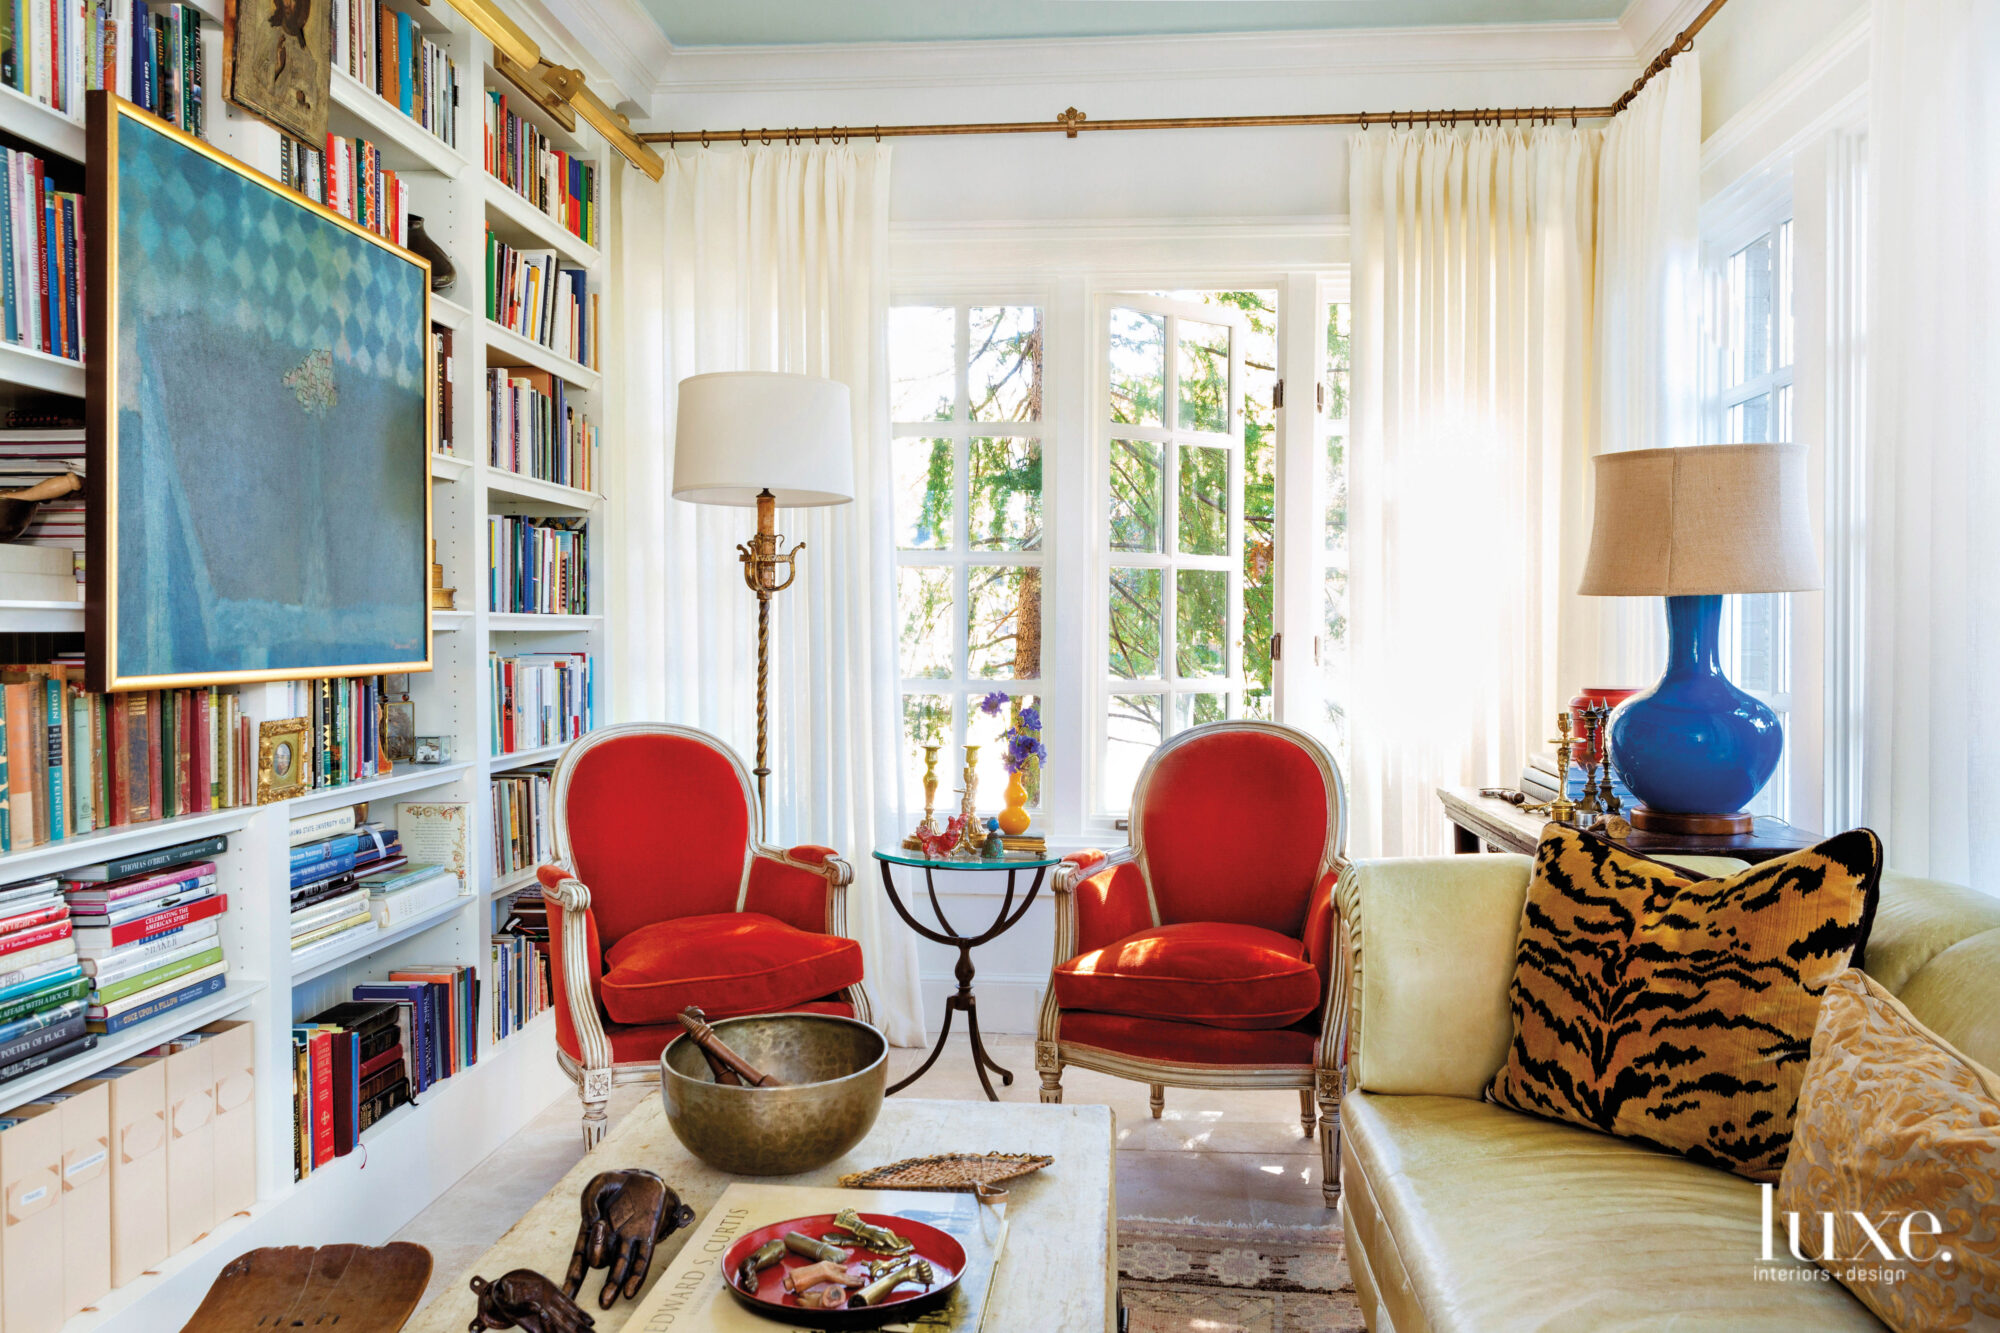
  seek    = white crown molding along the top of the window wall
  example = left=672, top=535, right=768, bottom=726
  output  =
left=640, top=21, right=1634, bottom=96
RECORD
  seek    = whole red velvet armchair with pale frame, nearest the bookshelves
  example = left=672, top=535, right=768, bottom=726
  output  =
left=540, top=723, right=868, bottom=1147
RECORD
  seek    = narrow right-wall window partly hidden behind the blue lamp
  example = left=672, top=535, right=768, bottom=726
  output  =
left=1704, top=214, right=1794, bottom=815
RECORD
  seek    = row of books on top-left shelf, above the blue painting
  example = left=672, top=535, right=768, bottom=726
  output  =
left=0, top=0, right=206, bottom=136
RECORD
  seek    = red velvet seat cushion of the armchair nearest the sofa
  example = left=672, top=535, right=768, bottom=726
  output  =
left=1056, top=921, right=1320, bottom=1029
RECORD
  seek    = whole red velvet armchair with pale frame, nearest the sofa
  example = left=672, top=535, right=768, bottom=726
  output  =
left=1034, top=723, right=1346, bottom=1205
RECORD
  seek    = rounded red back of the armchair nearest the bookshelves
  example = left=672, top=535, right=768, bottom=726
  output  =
left=554, top=723, right=752, bottom=951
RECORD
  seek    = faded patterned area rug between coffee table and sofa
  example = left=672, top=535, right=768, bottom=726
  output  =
left=1118, top=1217, right=1366, bottom=1333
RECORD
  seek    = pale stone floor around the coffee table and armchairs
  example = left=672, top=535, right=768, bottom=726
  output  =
left=396, top=1037, right=1336, bottom=1299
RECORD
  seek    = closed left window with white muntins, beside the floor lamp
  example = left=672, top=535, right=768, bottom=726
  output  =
left=890, top=304, right=1046, bottom=811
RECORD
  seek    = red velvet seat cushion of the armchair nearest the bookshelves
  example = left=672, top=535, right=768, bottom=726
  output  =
left=602, top=913, right=862, bottom=1023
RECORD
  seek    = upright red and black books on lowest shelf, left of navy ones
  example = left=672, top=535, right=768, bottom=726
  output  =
left=292, top=1001, right=410, bottom=1179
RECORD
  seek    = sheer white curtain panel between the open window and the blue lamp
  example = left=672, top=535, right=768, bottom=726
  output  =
left=1348, top=126, right=1598, bottom=857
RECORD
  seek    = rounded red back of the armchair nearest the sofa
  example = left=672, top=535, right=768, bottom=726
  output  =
left=1132, top=723, right=1346, bottom=939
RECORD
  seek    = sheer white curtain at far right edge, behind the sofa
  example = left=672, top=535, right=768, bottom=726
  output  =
left=1862, top=0, right=2000, bottom=880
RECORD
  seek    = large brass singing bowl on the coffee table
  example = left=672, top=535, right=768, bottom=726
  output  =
left=660, top=1013, right=888, bottom=1175
